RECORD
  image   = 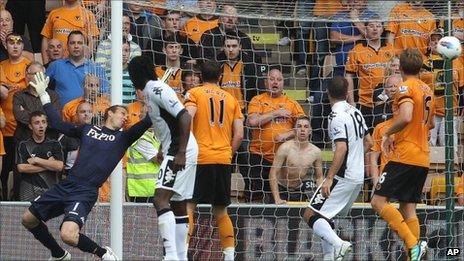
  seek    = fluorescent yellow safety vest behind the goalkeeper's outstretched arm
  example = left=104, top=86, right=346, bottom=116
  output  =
left=126, top=131, right=160, bottom=197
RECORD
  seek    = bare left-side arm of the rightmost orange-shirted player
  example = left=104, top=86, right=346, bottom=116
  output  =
left=381, top=102, right=414, bottom=156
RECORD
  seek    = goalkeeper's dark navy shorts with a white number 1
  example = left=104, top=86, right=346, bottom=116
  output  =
left=29, top=180, right=98, bottom=228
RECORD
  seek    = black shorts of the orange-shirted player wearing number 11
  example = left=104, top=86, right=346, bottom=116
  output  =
left=192, top=164, right=232, bottom=206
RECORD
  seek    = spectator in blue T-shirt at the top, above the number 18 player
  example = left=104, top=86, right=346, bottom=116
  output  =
left=330, top=0, right=374, bottom=76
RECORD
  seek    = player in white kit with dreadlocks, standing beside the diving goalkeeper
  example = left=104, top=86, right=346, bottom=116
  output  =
left=129, top=56, right=198, bottom=260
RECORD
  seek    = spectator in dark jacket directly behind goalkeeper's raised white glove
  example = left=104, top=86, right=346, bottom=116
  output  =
left=13, top=62, right=61, bottom=142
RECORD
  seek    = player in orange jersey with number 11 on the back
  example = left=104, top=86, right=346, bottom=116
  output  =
left=185, top=61, right=243, bottom=260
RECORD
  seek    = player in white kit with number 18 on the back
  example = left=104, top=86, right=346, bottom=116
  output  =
left=303, top=77, right=372, bottom=260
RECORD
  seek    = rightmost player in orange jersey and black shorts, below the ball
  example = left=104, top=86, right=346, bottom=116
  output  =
left=371, top=49, right=435, bottom=261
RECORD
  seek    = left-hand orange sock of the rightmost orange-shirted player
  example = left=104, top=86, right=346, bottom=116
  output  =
left=379, top=204, right=417, bottom=249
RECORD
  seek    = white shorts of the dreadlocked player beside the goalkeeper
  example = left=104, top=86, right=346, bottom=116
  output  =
left=155, top=155, right=197, bottom=201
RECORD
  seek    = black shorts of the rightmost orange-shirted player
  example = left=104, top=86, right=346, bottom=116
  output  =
left=374, top=161, right=429, bottom=203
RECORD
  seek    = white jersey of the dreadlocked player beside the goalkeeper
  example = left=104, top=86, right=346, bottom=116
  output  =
left=143, top=81, right=198, bottom=163
